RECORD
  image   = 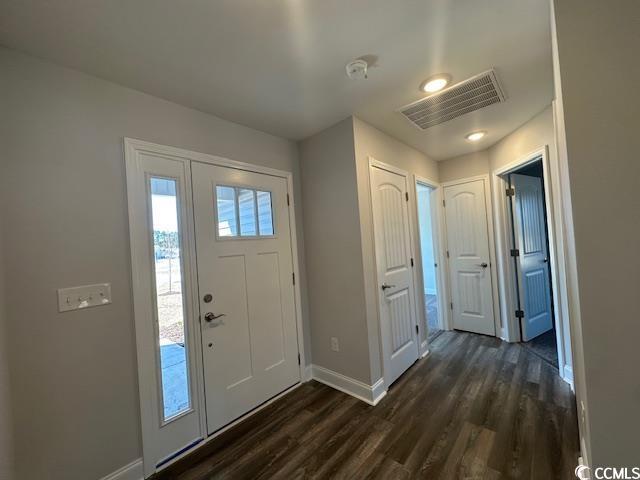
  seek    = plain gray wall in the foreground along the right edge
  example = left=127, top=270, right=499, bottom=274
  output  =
left=554, top=0, right=640, bottom=466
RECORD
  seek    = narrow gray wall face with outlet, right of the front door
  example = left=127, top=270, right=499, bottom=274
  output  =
left=300, top=118, right=372, bottom=383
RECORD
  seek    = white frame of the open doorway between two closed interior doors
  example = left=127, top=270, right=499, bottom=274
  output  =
left=412, top=174, right=452, bottom=357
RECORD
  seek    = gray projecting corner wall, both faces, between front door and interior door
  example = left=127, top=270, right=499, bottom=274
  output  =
left=300, top=117, right=438, bottom=385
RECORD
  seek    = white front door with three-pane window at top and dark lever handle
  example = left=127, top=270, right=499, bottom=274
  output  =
left=192, top=162, right=300, bottom=434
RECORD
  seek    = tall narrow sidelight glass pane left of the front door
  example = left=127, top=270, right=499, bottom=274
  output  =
left=151, top=178, right=191, bottom=421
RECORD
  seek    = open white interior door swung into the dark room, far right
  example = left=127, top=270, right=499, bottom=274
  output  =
left=511, top=174, right=553, bottom=342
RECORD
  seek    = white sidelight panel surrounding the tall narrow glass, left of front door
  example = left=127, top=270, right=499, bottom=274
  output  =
left=126, top=149, right=204, bottom=477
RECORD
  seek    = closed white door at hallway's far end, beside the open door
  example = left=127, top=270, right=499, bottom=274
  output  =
left=444, top=180, right=496, bottom=335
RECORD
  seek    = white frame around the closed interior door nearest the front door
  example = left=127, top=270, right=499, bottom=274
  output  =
left=368, top=157, right=428, bottom=391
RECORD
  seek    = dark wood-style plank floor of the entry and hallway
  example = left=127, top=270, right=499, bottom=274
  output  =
left=154, top=332, right=578, bottom=480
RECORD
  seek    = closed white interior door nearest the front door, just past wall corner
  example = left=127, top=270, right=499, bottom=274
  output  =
left=371, top=165, right=419, bottom=386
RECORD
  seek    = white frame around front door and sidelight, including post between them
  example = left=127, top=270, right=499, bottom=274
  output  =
left=124, top=137, right=306, bottom=477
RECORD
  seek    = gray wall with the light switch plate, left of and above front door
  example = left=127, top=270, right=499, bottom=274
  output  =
left=0, top=49, right=306, bottom=480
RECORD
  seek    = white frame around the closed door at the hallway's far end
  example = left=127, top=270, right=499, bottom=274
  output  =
left=441, top=175, right=505, bottom=340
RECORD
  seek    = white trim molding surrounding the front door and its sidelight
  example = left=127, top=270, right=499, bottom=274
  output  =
left=123, top=137, right=308, bottom=476
